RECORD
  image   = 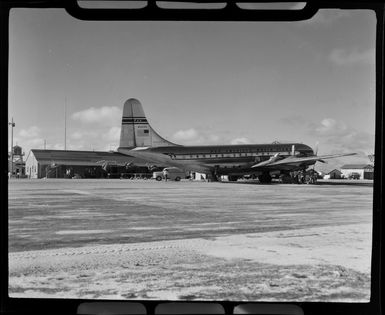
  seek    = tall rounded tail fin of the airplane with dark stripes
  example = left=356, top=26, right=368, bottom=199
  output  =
left=119, top=98, right=176, bottom=148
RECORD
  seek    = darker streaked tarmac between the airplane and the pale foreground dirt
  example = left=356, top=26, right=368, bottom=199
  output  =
left=9, top=179, right=372, bottom=252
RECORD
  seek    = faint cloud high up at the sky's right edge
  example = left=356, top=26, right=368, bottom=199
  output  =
left=329, top=49, right=375, bottom=66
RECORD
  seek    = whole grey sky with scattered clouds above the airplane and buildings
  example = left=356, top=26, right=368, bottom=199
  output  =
left=8, top=8, right=376, bottom=170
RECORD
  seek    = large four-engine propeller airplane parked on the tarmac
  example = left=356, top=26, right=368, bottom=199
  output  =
left=118, top=98, right=356, bottom=183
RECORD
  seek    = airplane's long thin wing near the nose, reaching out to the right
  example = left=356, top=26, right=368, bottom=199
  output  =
left=252, top=153, right=357, bottom=169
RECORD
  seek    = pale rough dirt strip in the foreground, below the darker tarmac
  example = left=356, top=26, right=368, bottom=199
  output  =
left=10, top=225, right=370, bottom=302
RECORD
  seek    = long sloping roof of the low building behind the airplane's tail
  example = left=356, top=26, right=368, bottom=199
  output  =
left=27, top=149, right=145, bottom=165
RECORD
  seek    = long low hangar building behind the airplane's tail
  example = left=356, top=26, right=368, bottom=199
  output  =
left=25, top=149, right=152, bottom=178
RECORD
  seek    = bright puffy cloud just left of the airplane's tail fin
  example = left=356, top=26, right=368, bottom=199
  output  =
left=71, top=106, right=122, bottom=125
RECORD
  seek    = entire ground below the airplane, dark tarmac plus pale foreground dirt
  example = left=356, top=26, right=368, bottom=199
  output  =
left=9, top=179, right=373, bottom=301
